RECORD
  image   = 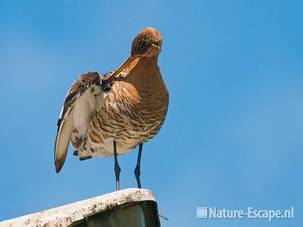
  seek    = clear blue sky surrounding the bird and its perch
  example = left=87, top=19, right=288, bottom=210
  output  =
left=0, top=0, right=303, bottom=227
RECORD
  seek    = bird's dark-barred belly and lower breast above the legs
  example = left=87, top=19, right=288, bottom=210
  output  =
left=73, top=80, right=168, bottom=157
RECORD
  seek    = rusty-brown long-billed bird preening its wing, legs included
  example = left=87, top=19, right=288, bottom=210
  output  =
left=54, top=27, right=169, bottom=190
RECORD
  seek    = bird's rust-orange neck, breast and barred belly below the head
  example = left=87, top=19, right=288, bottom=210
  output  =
left=79, top=55, right=168, bottom=155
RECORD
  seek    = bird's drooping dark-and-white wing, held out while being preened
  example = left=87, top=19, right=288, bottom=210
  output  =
left=54, top=73, right=105, bottom=173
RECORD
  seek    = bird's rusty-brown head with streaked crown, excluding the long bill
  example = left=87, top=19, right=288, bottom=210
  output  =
left=131, top=27, right=162, bottom=57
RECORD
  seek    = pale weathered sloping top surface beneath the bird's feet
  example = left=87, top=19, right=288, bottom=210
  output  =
left=0, top=188, right=155, bottom=227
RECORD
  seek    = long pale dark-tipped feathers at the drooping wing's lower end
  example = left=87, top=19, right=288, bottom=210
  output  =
left=54, top=119, right=72, bottom=173
